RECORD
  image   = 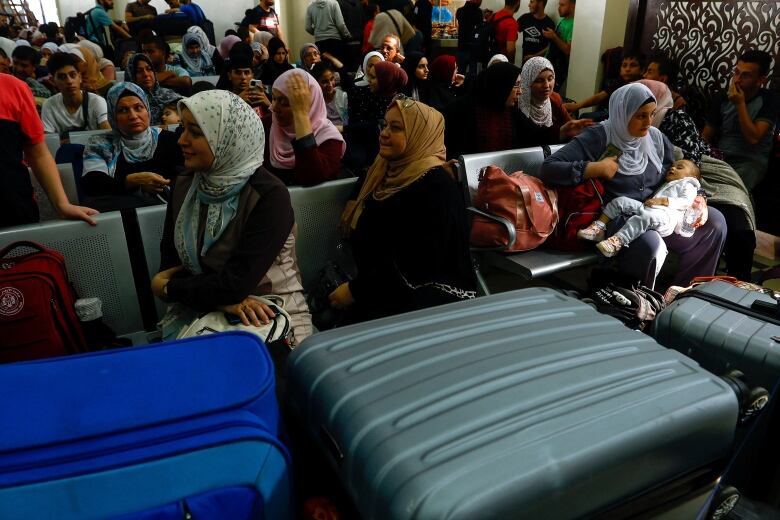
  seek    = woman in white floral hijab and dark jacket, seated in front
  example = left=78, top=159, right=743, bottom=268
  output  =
left=152, top=90, right=312, bottom=345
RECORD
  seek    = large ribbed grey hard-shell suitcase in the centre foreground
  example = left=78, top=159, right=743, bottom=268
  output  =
left=288, top=288, right=738, bottom=520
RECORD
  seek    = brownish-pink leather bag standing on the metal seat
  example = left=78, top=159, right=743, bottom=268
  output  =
left=471, top=166, right=558, bottom=252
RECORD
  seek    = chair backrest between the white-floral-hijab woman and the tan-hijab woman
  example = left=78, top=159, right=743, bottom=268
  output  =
left=290, top=178, right=357, bottom=290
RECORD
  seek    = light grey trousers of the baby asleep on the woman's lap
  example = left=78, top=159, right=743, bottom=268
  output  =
left=604, top=197, right=679, bottom=245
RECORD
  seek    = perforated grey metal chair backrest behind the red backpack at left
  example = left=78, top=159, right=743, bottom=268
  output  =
left=0, top=211, right=144, bottom=335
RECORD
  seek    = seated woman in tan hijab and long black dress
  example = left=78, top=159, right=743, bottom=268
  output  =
left=330, top=96, right=476, bottom=321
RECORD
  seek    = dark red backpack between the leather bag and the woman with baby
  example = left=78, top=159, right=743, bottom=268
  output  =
left=547, top=179, right=604, bottom=251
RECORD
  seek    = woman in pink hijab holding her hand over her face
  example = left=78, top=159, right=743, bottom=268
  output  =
left=263, top=69, right=346, bottom=185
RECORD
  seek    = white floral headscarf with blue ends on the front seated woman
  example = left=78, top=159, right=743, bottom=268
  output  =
left=173, top=90, right=265, bottom=274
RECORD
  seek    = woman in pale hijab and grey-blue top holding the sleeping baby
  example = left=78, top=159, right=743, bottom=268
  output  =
left=539, top=83, right=726, bottom=287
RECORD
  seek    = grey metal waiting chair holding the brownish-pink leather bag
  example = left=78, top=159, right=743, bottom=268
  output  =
left=458, top=145, right=599, bottom=292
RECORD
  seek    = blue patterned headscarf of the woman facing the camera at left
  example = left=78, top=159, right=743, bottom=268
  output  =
left=84, top=83, right=160, bottom=178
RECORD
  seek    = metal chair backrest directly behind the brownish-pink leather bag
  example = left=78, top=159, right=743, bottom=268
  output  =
left=458, top=146, right=544, bottom=205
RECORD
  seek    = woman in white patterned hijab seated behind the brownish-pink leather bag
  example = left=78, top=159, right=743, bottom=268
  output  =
left=518, top=56, right=593, bottom=148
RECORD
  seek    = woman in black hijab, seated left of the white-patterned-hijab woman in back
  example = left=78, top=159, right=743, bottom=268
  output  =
left=446, top=63, right=521, bottom=158
